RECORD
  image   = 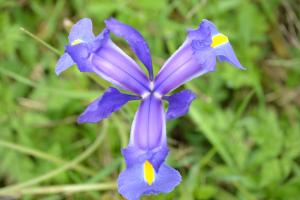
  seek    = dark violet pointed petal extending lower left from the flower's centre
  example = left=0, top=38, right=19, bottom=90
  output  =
left=78, top=87, right=139, bottom=123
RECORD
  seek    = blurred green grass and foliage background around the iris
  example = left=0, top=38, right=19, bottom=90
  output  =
left=0, top=0, right=300, bottom=200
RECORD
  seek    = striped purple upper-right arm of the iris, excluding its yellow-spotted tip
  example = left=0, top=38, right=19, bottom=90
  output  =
left=155, top=24, right=216, bottom=96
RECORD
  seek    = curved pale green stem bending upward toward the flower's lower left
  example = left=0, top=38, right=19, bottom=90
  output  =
left=0, top=123, right=107, bottom=195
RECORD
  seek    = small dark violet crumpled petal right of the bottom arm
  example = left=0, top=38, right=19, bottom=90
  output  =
left=164, top=90, right=196, bottom=120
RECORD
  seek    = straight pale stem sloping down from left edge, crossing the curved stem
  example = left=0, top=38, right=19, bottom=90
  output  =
left=0, top=140, right=95, bottom=175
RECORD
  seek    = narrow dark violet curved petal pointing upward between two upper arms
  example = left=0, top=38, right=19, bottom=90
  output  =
left=105, top=18, right=153, bottom=80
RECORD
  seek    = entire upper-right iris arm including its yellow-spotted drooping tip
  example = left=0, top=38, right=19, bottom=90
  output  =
left=155, top=20, right=243, bottom=96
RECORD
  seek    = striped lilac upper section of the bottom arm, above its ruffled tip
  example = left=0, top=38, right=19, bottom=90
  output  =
left=129, top=94, right=166, bottom=151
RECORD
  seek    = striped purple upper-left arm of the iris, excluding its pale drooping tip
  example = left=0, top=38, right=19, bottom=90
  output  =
left=66, top=29, right=149, bottom=95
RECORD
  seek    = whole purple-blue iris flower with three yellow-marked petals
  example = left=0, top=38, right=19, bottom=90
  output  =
left=56, top=18, right=244, bottom=200
